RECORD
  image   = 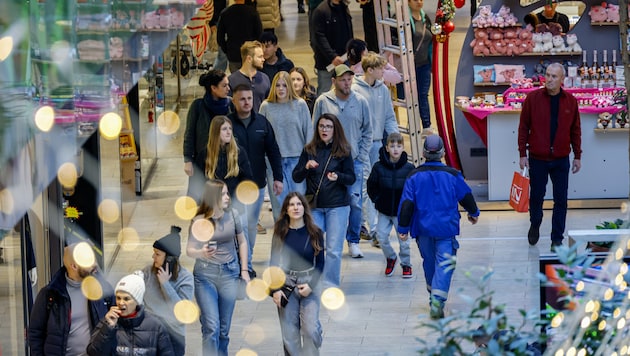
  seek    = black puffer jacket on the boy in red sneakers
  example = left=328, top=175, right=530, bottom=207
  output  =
left=367, top=147, right=415, bottom=216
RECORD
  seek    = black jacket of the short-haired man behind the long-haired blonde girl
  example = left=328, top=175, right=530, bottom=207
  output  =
left=228, top=111, right=282, bottom=189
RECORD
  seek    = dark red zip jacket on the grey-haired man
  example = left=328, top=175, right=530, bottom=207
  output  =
left=518, top=88, right=582, bottom=161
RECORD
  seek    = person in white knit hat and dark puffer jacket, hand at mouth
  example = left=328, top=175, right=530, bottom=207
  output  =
left=87, top=271, right=174, bottom=356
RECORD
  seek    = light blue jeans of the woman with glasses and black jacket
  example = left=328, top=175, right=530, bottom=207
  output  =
left=313, top=205, right=350, bottom=288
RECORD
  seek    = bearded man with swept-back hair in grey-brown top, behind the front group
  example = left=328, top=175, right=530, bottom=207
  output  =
left=228, top=41, right=271, bottom=112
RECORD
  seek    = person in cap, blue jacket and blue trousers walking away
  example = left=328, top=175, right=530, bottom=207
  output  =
left=398, top=135, right=479, bottom=319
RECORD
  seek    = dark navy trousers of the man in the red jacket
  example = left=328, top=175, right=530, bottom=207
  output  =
left=529, top=157, right=571, bottom=242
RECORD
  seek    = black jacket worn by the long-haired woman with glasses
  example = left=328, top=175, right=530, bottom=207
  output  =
left=293, top=144, right=356, bottom=208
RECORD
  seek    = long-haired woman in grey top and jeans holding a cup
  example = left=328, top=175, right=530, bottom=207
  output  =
left=186, top=179, right=249, bottom=356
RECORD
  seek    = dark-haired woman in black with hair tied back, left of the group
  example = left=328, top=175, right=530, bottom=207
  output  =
left=184, top=70, right=233, bottom=204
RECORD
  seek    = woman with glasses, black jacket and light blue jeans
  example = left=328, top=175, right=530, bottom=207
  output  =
left=293, top=114, right=356, bottom=287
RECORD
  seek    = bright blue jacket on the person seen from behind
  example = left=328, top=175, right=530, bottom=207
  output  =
left=398, top=161, right=479, bottom=238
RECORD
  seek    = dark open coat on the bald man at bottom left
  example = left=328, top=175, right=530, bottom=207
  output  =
left=28, top=267, right=114, bottom=355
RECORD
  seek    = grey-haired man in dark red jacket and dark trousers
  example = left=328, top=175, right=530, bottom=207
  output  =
left=518, top=63, right=582, bottom=251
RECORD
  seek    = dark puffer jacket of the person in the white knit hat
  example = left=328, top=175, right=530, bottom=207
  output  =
left=87, top=306, right=174, bottom=356
